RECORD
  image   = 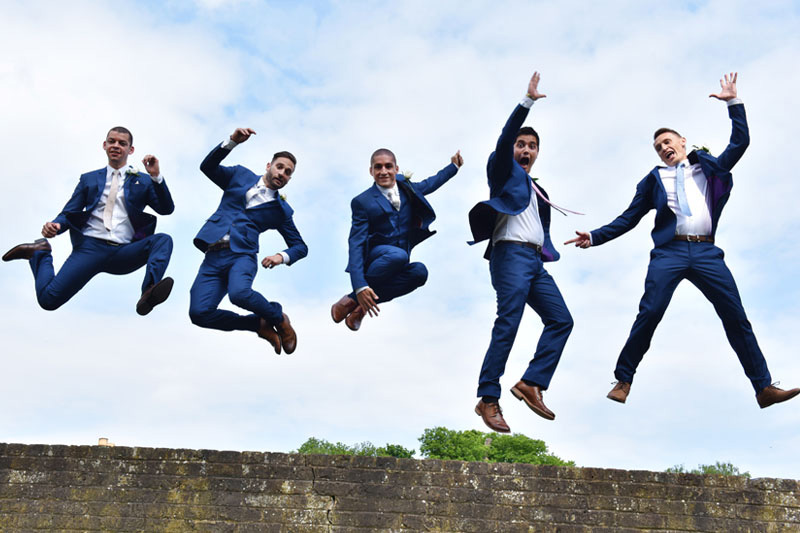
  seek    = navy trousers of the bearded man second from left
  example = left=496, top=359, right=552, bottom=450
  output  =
left=189, top=249, right=283, bottom=331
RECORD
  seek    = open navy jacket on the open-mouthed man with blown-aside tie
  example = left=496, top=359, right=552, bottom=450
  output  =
left=469, top=105, right=561, bottom=261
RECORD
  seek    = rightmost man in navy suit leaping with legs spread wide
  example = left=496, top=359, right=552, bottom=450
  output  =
left=565, top=73, right=800, bottom=409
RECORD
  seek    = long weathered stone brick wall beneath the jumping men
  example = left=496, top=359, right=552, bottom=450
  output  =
left=0, top=444, right=800, bottom=533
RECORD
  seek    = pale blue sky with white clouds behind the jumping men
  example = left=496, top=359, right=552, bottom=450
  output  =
left=0, top=0, right=800, bottom=479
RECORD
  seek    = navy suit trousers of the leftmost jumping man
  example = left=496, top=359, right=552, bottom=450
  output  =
left=30, top=233, right=172, bottom=311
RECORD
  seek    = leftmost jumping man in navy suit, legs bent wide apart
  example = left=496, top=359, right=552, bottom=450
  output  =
left=3, top=126, right=175, bottom=315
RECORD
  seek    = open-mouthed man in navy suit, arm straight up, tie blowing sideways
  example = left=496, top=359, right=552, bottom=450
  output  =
left=469, top=72, right=573, bottom=433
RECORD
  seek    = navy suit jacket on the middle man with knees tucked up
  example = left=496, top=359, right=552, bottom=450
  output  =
left=345, top=163, right=458, bottom=290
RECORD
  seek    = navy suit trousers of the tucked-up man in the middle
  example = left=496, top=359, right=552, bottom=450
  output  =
left=350, top=244, right=428, bottom=305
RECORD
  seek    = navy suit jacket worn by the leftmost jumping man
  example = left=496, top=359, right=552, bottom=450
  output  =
left=53, top=167, right=175, bottom=247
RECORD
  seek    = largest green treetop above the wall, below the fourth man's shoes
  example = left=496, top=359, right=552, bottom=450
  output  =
left=419, top=427, right=575, bottom=466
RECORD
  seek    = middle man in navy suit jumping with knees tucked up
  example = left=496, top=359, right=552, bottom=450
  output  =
left=331, top=148, right=464, bottom=331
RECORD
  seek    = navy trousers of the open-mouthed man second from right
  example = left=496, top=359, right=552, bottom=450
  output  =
left=478, top=241, right=573, bottom=398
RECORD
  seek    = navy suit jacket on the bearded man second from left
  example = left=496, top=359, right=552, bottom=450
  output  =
left=194, top=144, right=308, bottom=264
